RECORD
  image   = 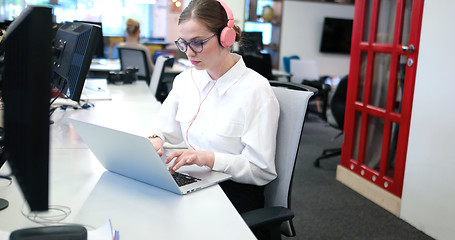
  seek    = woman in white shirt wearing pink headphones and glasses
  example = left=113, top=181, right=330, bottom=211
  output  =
left=150, top=0, right=279, bottom=213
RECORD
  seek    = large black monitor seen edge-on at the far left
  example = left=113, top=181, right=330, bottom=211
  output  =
left=2, top=6, right=52, bottom=211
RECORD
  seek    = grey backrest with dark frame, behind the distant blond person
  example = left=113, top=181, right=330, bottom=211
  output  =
left=118, top=48, right=150, bottom=85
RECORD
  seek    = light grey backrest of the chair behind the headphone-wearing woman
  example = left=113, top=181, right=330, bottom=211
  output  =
left=264, top=81, right=317, bottom=236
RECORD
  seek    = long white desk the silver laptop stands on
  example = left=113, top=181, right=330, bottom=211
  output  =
left=0, top=82, right=255, bottom=239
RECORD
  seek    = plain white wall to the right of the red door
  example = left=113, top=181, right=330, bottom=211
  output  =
left=401, top=0, right=455, bottom=240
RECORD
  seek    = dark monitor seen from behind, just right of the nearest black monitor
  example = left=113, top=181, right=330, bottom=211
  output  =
left=51, top=22, right=101, bottom=102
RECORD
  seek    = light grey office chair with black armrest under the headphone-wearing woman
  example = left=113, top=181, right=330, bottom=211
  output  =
left=242, top=81, right=317, bottom=239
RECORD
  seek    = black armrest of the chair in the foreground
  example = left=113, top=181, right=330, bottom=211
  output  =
left=241, top=207, right=294, bottom=229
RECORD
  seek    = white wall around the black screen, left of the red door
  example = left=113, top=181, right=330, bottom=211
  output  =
left=280, top=1, right=354, bottom=76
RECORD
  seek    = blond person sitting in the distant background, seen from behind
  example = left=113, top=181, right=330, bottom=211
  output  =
left=118, top=18, right=153, bottom=74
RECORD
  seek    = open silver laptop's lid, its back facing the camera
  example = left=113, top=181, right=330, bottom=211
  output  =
left=70, top=119, right=181, bottom=194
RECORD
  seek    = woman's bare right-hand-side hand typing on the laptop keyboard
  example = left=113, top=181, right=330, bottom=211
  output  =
left=166, top=150, right=215, bottom=173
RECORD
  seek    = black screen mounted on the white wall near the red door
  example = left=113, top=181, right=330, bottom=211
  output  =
left=320, top=17, right=353, bottom=54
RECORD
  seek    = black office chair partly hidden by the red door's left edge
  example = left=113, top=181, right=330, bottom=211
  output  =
left=313, top=75, right=348, bottom=167
